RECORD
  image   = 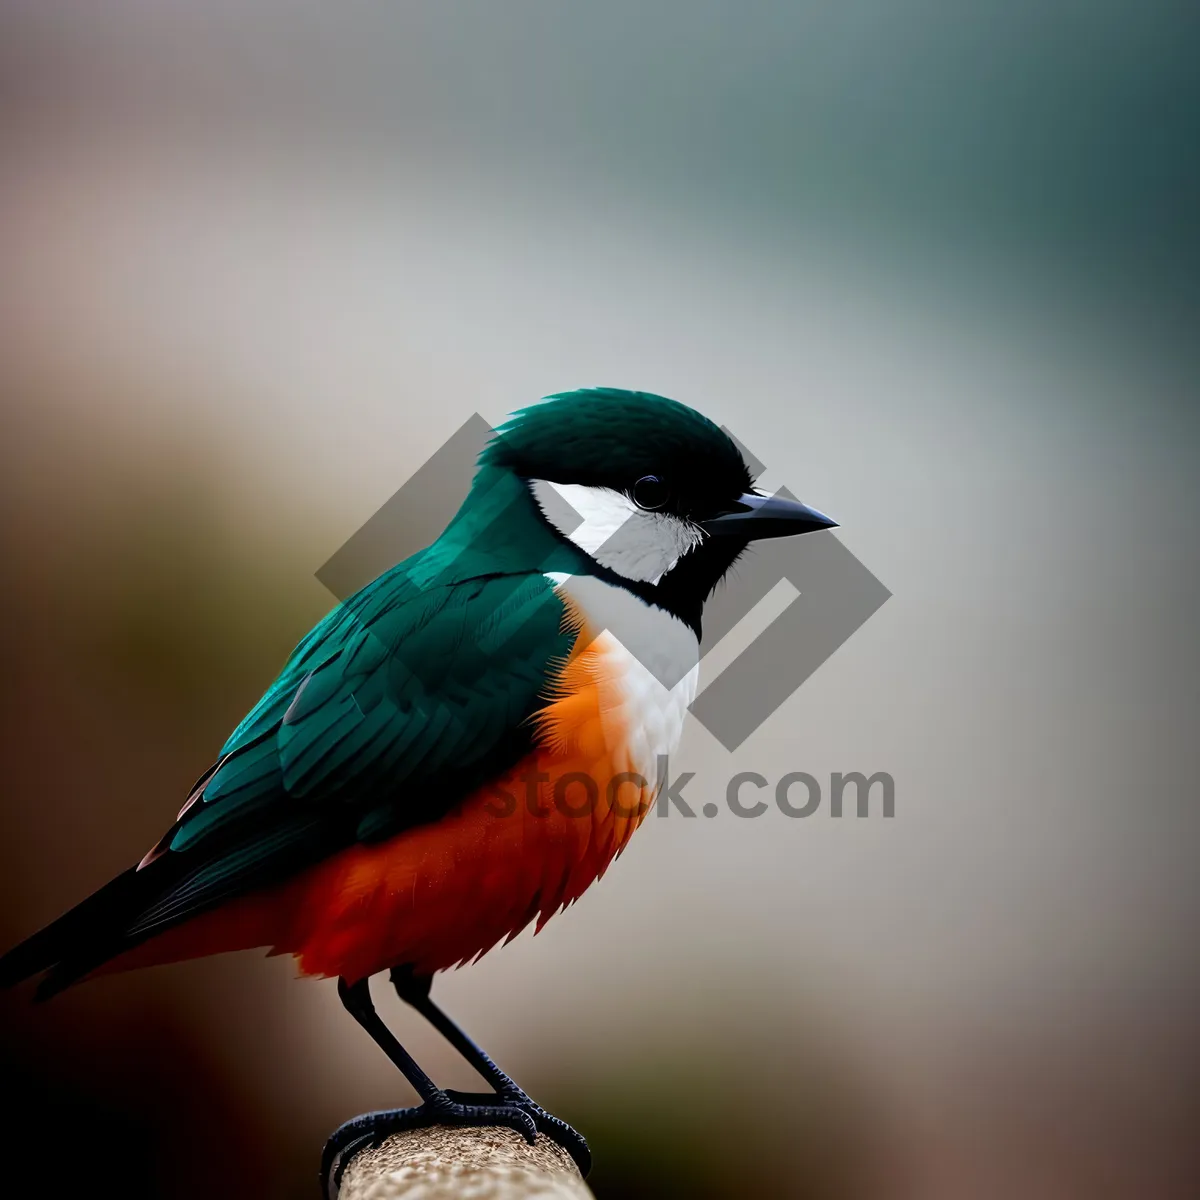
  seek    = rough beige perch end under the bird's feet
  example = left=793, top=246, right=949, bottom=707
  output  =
left=338, top=1126, right=594, bottom=1200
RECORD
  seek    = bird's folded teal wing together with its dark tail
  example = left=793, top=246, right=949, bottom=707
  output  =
left=13, top=551, right=571, bottom=995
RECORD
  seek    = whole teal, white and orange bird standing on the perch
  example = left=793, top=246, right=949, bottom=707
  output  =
left=0, top=388, right=835, bottom=1196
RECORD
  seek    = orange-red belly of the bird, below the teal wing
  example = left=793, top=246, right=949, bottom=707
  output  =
left=112, top=604, right=655, bottom=980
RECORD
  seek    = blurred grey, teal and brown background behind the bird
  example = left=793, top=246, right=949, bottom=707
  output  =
left=0, top=0, right=1200, bottom=1200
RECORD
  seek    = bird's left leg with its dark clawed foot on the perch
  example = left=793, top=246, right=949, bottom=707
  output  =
left=320, top=979, right=538, bottom=1200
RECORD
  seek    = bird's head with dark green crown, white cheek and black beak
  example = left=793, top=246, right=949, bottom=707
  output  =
left=481, top=388, right=835, bottom=624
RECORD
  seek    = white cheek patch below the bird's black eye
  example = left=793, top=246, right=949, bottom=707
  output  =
left=529, top=479, right=704, bottom=583
